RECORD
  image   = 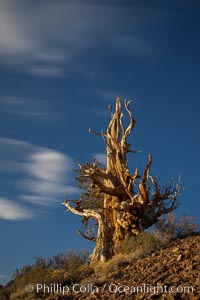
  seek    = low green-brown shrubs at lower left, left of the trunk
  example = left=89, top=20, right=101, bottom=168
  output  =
left=0, top=250, right=89, bottom=300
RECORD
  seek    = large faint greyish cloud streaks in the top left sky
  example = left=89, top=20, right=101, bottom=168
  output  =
left=0, top=0, right=154, bottom=77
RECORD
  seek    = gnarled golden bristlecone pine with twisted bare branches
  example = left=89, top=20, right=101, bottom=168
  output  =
left=64, top=98, right=181, bottom=263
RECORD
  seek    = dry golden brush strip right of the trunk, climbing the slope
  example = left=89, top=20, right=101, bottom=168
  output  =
left=82, top=213, right=199, bottom=284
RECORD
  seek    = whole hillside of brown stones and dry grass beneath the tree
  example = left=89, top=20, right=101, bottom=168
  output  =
left=0, top=233, right=200, bottom=300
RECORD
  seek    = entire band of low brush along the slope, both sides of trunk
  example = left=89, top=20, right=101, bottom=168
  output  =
left=0, top=213, right=199, bottom=300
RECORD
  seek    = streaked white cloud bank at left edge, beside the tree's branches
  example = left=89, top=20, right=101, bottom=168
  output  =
left=0, top=138, right=79, bottom=220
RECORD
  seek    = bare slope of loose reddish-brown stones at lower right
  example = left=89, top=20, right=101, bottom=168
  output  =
left=66, top=234, right=200, bottom=300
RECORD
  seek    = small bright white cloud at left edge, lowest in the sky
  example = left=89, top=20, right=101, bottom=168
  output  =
left=0, top=197, right=34, bottom=221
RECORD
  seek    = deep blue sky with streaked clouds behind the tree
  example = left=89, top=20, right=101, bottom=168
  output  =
left=0, top=0, right=200, bottom=284
